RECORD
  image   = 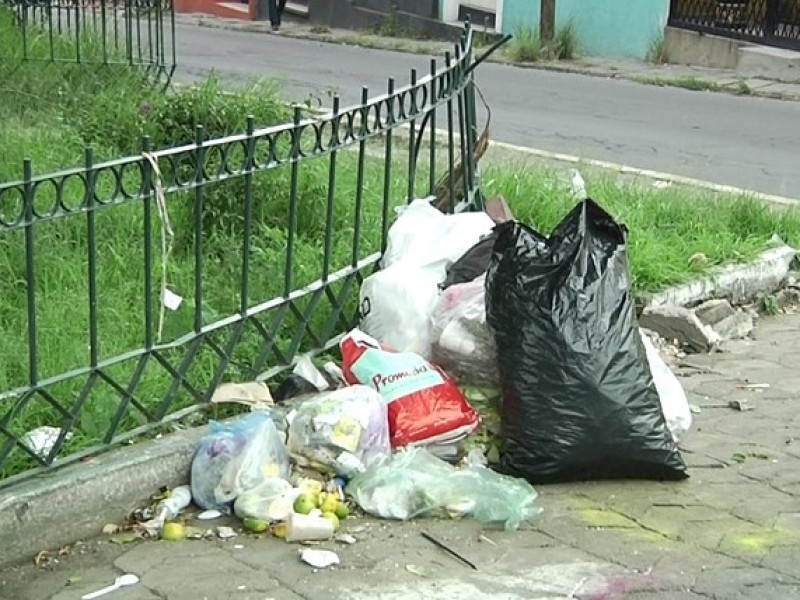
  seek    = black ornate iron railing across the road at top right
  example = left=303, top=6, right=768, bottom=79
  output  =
left=669, top=0, right=800, bottom=49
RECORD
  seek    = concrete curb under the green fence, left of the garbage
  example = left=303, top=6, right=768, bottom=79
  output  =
left=0, top=428, right=204, bottom=568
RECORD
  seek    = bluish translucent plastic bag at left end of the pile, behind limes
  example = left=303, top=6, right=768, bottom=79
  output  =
left=191, top=411, right=290, bottom=511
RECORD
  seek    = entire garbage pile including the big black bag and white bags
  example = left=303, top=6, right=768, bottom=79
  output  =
left=125, top=199, right=692, bottom=560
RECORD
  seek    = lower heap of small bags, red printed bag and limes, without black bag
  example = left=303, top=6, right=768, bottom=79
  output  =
left=178, top=342, right=540, bottom=542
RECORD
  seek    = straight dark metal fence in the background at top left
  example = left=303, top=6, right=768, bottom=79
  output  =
left=0, top=0, right=175, bottom=79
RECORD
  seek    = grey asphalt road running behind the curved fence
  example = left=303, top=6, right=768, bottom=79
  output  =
left=177, top=25, right=800, bottom=198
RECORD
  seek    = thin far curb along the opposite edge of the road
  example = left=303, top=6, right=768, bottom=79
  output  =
left=183, top=15, right=800, bottom=102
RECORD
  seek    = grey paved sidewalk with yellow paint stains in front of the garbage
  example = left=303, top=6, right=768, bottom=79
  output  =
left=0, top=315, right=800, bottom=600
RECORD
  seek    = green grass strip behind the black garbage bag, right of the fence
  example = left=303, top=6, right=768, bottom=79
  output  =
left=484, top=167, right=800, bottom=294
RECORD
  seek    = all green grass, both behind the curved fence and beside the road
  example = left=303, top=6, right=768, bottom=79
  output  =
left=0, top=11, right=800, bottom=480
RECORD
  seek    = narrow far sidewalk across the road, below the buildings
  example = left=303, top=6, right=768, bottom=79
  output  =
left=175, top=13, right=800, bottom=100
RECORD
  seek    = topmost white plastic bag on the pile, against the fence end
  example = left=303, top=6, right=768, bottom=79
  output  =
left=381, top=199, right=495, bottom=276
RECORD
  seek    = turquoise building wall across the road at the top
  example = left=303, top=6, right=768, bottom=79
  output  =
left=502, top=0, right=669, bottom=58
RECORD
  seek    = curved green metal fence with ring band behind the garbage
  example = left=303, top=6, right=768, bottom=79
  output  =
left=0, top=21, right=496, bottom=486
